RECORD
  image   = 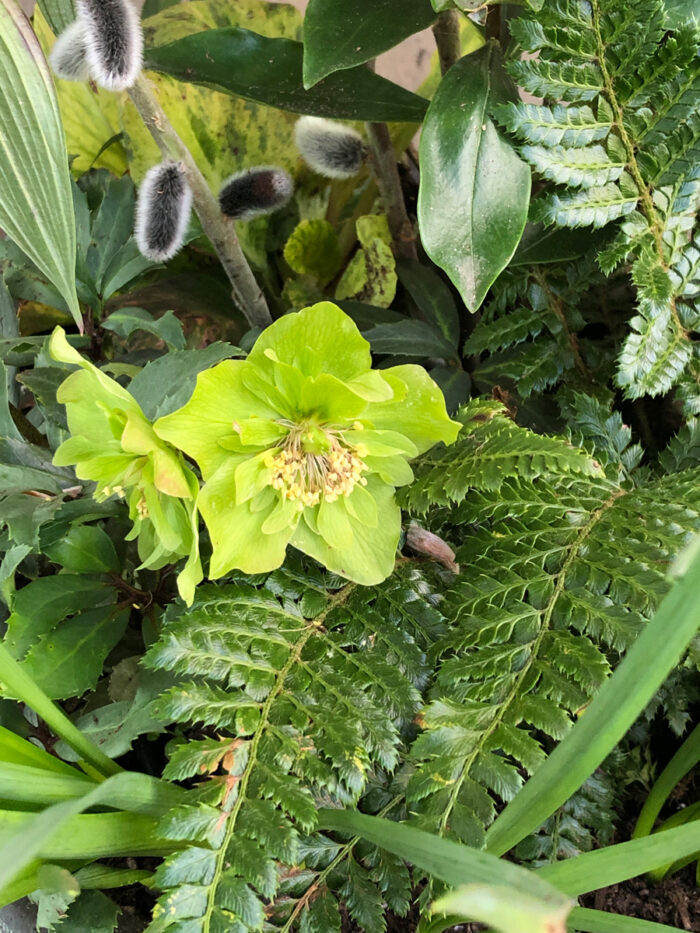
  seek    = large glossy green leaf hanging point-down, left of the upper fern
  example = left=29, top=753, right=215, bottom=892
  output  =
left=418, top=42, right=530, bottom=311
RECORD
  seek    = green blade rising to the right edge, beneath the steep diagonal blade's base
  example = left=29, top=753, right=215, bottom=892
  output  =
left=537, top=821, right=700, bottom=896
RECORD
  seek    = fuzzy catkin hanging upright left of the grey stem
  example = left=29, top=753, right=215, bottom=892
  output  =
left=134, top=162, right=192, bottom=262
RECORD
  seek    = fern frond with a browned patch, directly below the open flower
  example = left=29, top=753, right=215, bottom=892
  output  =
left=147, top=564, right=445, bottom=933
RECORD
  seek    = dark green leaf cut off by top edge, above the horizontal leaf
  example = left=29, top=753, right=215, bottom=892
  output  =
left=304, top=0, right=435, bottom=88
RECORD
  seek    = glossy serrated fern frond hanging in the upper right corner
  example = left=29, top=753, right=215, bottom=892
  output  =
left=498, top=0, right=700, bottom=400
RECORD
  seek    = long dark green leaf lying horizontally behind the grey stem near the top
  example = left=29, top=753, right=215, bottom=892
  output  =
left=146, top=27, right=428, bottom=123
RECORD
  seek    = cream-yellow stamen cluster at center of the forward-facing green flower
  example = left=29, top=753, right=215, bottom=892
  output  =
left=265, top=423, right=367, bottom=506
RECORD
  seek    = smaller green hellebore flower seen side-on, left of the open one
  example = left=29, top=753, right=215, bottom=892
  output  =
left=49, top=327, right=202, bottom=605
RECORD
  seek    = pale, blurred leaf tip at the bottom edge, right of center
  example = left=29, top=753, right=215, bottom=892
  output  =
left=432, top=884, right=574, bottom=933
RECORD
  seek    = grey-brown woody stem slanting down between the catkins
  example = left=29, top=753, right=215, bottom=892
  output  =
left=129, top=74, right=272, bottom=327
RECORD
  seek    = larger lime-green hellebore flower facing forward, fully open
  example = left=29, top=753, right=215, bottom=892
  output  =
left=154, top=302, right=460, bottom=585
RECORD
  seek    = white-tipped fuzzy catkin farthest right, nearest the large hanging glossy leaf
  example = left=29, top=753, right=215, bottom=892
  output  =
left=294, top=117, right=365, bottom=178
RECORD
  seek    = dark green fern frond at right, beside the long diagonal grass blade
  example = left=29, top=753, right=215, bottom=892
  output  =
left=408, top=456, right=700, bottom=845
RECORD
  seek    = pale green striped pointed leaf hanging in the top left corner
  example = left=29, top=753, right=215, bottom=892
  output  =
left=0, top=0, right=82, bottom=326
